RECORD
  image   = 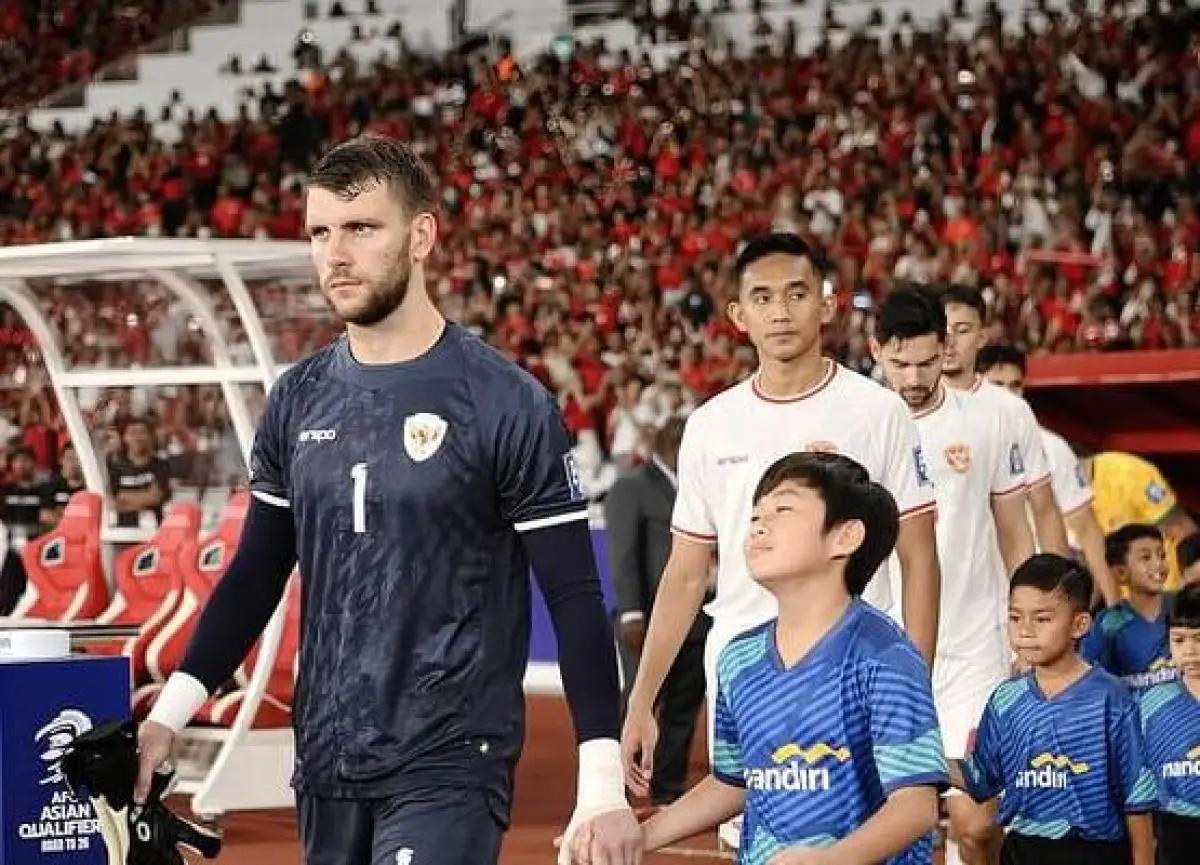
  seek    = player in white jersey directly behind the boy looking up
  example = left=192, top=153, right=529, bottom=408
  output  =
left=622, top=233, right=938, bottom=811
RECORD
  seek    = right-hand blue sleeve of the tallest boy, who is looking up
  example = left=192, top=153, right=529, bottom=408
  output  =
left=866, top=644, right=949, bottom=795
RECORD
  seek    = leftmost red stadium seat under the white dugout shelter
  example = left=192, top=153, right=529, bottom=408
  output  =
left=12, top=489, right=108, bottom=621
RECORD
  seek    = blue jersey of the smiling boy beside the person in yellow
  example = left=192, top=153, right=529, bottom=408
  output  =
left=1079, top=594, right=1176, bottom=695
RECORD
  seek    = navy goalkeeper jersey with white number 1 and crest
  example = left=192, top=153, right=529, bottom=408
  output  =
left=250, top=324, right=587, bottom=797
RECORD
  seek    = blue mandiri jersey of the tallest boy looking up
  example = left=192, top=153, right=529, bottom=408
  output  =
left=713, top=599, right=948, bottom=865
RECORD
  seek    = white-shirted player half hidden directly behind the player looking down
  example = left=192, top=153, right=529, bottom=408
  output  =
left=942, top=286, right=1068, bottom=556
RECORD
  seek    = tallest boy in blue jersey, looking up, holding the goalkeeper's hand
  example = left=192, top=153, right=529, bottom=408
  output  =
left=644, top=453, right=947, bottom=865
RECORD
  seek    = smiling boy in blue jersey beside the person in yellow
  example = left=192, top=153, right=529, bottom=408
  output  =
left=1080, top=523, right=1175, bottom=695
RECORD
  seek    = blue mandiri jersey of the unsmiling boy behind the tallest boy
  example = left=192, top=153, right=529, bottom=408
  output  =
left=962, top=667, right=1158, bottom=841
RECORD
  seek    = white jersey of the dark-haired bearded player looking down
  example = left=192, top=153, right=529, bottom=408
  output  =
left=913, top=388, right=1026, bottom=660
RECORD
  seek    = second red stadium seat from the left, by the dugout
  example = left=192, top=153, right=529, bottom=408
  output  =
left=89, top=501, right=200, bottom=684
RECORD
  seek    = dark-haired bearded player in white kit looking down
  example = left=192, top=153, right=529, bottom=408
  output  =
left=871, top=288, right=1034, bottom=865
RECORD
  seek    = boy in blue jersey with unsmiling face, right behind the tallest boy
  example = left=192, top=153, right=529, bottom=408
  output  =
left=950, top=553, right=1158, bottom=865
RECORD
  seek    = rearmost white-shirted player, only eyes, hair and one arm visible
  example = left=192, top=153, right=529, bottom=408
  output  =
left=976, top=346, right=1121, bottom=605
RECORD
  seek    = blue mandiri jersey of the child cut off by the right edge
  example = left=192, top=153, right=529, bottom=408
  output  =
left=1141, top=680, right=1200, bottom=819
